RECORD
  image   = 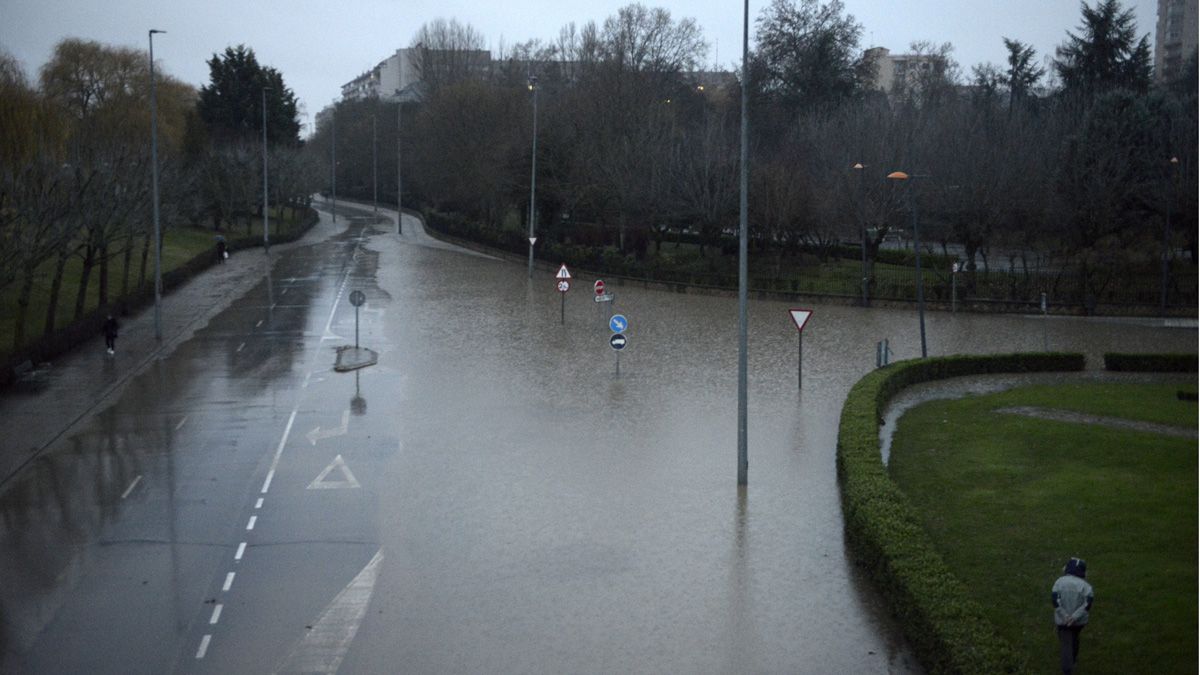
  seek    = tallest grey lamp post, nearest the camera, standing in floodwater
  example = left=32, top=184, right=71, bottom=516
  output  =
left=738, top=0, right=750, bottom=485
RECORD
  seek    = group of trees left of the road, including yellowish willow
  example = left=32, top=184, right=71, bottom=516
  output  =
left=0, top=38, right=323, bottom=351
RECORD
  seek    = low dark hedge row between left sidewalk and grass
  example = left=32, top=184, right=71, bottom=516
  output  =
left=0, top=209, right=318, bottom=387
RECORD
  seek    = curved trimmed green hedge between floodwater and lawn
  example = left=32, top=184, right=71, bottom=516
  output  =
left=838, top=353, right=1085, bottom=674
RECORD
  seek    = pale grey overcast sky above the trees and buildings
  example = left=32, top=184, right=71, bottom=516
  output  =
left=0, top=0, right=1157, bottom=130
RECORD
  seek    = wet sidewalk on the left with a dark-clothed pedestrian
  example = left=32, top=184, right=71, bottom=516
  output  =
left=0, top=211, right=345, bottom=485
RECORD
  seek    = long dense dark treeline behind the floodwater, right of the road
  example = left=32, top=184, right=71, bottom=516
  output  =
left=308, top=0, right=1198, bottom=305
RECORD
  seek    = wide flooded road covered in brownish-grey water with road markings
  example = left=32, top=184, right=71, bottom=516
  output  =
left=0, top=201, right=1196, bottom=673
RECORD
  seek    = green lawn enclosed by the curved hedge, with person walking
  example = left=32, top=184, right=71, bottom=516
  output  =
left=889, top=383, right=1198, bottom=674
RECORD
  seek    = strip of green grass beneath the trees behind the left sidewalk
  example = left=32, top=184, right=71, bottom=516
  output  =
left=0, top=209, right=302, bottom=360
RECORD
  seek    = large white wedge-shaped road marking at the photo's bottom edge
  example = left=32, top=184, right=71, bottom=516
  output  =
left=275, top=549, right=383, bottom=675
